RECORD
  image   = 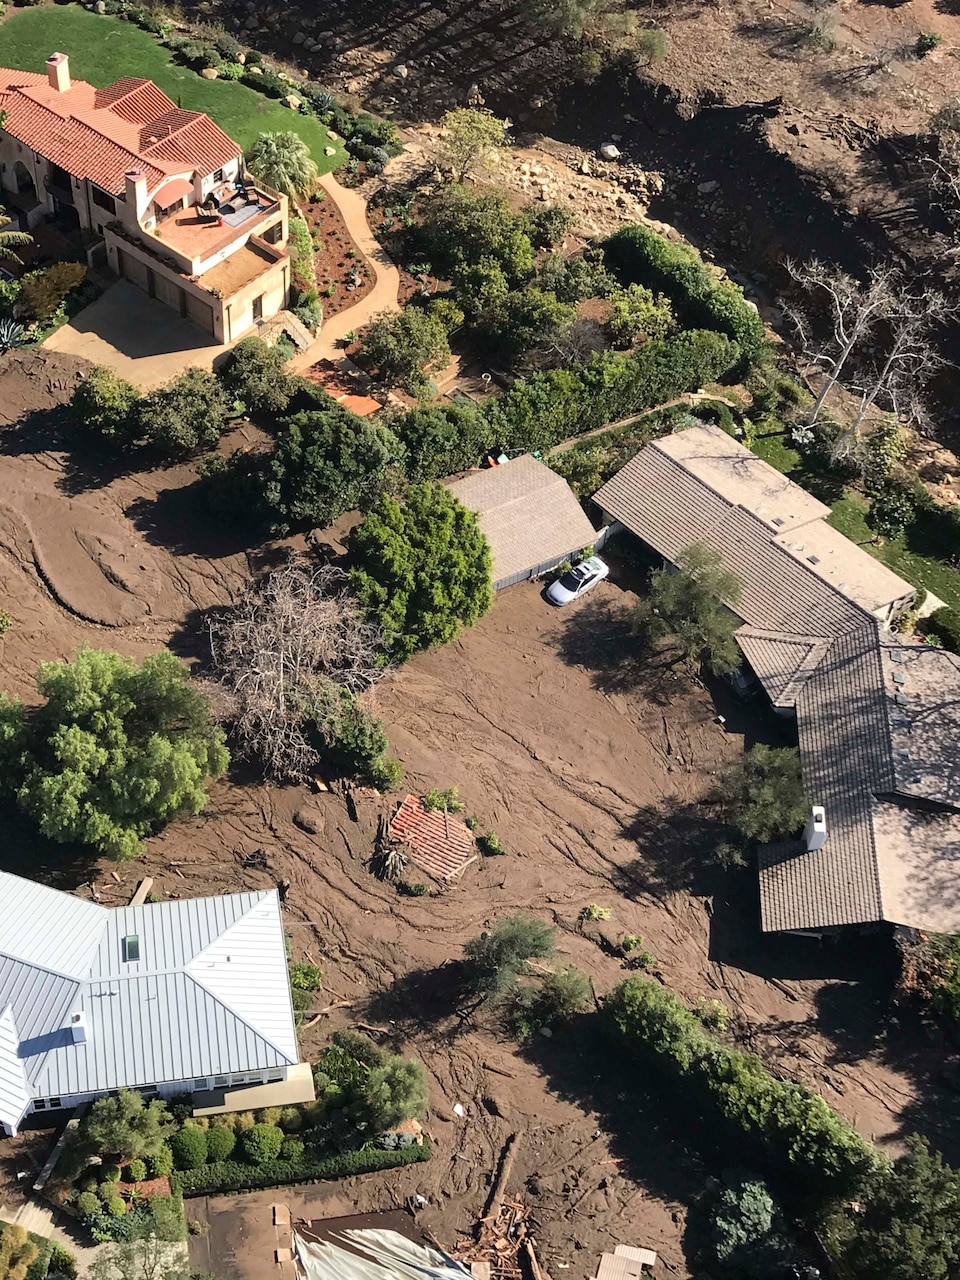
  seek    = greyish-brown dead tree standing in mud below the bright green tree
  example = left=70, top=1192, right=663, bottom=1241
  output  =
left=209, top=559, right=387, bottom=781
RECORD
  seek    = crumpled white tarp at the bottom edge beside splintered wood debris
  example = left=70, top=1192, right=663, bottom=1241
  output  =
left=293, top=1230, right=470, bottom=1280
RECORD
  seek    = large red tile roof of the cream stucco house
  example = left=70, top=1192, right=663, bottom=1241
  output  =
left=0, top=68, right=241, bottom=195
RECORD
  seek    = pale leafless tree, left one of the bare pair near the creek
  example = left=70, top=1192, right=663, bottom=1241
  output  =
left=786, top=259, right=896, bottom=426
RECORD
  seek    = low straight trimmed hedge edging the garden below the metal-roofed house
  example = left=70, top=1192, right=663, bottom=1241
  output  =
left=170, top=1139, right=430, bottom=1196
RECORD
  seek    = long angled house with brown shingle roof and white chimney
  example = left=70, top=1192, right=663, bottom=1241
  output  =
left=595, top=426, right=960, bottom=933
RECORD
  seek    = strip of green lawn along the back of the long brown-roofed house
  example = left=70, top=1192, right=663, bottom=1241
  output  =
left=753, top=433, right=960, bottom=608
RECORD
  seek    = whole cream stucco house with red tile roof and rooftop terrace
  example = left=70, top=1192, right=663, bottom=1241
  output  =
left=0, top=54, right=289, bottom=343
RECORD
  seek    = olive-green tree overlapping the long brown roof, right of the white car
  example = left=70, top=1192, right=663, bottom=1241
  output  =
left=634, top=543, right=741, bottom=675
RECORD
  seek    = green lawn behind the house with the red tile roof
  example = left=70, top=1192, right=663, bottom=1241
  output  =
left=0, top=5, right=346, bottom=173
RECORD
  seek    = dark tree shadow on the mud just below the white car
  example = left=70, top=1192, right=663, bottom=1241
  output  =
left=548, top=600, right=687, bottom=707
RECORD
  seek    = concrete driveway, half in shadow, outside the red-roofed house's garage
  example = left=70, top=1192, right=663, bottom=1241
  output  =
left=44, top=280, right=227, bottom=390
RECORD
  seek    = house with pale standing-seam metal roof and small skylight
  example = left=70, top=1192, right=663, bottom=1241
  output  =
left=0, top=872, right=314, bottom=1134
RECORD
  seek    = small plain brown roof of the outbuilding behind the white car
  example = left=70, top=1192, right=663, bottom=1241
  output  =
left=449, top=453, right=596, bottom=586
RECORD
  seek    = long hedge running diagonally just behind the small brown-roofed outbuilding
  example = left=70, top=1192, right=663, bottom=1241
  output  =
left=486, top=329, right=740, bottom=452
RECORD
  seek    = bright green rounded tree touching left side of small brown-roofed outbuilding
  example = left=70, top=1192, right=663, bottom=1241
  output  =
left=352, top=484, right=492, bottom=662
